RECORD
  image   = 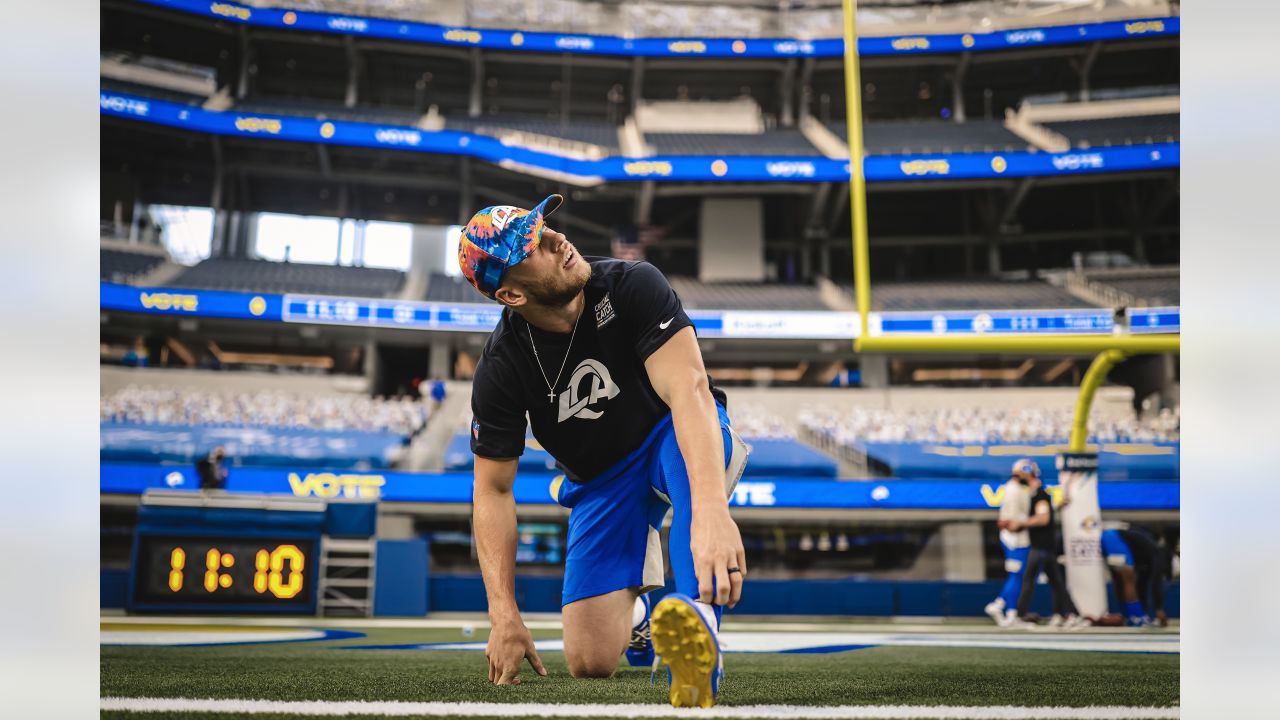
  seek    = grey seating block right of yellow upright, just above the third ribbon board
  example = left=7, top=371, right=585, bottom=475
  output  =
left=844, top=281, right=1092, bottom=310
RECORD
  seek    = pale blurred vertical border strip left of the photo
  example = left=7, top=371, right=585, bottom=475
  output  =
left=0, top=0, right=100, bottom=717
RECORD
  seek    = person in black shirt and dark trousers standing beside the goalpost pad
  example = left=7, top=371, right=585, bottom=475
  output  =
left=1000, top=462, right=1084, bottom=628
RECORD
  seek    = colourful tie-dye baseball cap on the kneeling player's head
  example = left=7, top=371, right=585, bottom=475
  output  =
left=458, top=195, right=564, bottom=300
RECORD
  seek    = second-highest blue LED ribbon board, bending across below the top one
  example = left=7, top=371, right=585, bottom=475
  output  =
left=99, top=91, right=1181, bottom=182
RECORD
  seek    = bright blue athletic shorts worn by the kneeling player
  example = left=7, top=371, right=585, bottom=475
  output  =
left=552, top=404, right=750, bottom=605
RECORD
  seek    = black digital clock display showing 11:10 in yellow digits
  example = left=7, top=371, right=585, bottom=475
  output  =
left=134, top=534, right=316, bottom=610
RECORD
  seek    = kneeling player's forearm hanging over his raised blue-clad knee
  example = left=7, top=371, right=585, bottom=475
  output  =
left=669, top=373, right=728, bottom=512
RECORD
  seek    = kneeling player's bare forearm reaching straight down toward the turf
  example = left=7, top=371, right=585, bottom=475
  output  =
left=472, top=488, right=520, bottom=621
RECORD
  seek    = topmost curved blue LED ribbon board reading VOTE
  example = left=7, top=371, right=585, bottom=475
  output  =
left=140, top=0, right=1181, bottom=58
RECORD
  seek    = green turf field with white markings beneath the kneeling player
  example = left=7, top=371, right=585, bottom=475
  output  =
left=100, top=616, right=1179, bottom=720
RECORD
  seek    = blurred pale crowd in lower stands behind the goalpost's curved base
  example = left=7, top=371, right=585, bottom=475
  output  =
left=797, top=407, right=1180, bottom=445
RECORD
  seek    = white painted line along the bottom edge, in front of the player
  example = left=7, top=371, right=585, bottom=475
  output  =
left=100, top=697, right=1179, bottom=720
